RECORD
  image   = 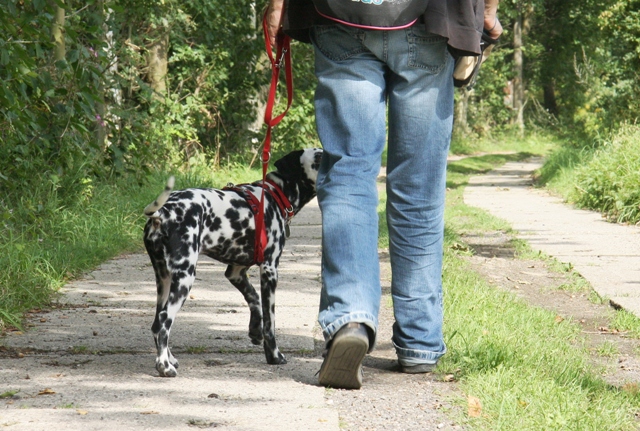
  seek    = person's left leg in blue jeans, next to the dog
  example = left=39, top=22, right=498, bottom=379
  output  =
left=312, top=25, right=386, bottom=348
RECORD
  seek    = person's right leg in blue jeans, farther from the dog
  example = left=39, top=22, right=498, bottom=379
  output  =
left=387, top=25, right=453, bottom=371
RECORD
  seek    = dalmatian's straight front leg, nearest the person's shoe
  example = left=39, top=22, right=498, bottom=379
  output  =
left=260, top=262, right=287, bottom=365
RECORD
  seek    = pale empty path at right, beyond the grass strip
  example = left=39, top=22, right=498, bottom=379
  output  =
left=464, top=159, right=640, bottom=316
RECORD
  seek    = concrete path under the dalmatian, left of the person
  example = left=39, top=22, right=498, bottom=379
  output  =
left=0, top=201, right=339, bottom=431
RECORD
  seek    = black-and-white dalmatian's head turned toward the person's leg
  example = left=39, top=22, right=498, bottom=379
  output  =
left=269, top=148, right=322, bottom=209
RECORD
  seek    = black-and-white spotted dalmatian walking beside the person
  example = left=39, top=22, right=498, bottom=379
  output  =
left=144, top=148, right=322, bottom=377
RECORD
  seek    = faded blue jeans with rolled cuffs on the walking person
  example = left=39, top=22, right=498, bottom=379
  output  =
left=312, top=24, right=453, bottom=365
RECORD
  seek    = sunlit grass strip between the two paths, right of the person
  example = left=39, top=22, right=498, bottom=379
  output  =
left=379, top=139, right=640, bottom=431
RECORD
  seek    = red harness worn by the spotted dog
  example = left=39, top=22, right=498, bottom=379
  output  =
left=222, top=180, right=294, bottom=264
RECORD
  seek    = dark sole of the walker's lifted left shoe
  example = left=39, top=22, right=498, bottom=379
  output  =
left=318, top=335, right=369, bottom=389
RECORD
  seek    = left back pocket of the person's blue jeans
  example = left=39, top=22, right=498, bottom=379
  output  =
left=311, top=25, right=367, bottom=61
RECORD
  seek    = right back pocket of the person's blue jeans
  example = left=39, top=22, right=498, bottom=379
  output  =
left=407, top=26, right=448, bottom=75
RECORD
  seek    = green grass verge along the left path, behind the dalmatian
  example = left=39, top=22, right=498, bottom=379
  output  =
left=0, top=166, right=261, bottom=330
